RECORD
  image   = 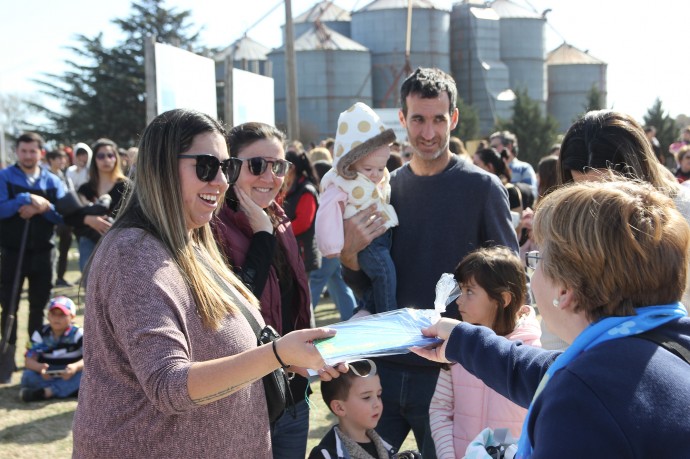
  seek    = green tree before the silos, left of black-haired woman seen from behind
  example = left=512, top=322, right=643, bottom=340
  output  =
left=496, top=89, right=558, bottom=167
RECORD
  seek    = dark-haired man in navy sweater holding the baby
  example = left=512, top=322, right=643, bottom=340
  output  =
left=341, top=68, right=518, bottom=459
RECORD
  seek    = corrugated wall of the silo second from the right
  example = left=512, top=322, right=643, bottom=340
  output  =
left=500, top=18, right=547, bottom=112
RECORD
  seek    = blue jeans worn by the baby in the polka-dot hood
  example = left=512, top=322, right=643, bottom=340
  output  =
left=357, top=229, right=398, bottom=313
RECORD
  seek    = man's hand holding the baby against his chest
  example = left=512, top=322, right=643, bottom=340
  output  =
left=340, top=204, right=386, bottom=271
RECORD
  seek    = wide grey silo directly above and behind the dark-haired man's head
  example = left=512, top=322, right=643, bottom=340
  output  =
left=351, top=0, right=450, bottom=108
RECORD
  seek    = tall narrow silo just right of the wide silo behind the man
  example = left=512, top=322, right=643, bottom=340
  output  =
left=450, top=1, right=515, bottom=135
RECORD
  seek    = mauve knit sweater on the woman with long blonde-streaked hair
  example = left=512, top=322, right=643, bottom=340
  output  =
left=73, top=228, right=272, bottom=458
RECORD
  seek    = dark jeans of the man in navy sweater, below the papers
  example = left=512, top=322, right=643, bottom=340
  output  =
left=376, top=359, right=439, bottom=459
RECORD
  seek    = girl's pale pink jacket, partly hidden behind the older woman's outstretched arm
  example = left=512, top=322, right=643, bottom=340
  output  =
left=429, top=306, right=541, bottom=459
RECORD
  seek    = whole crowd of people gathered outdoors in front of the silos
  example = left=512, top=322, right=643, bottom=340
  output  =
left=0, top=68, right=690, bottom=459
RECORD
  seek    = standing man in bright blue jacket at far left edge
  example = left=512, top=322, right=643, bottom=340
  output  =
left=0, top=132, right=65, bottom=382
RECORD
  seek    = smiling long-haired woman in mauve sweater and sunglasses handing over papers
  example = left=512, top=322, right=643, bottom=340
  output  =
left=73, top=109, right=338, bottom=458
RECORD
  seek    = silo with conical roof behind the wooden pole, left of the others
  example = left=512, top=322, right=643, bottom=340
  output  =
left=268, top=23, right=372, bottom=145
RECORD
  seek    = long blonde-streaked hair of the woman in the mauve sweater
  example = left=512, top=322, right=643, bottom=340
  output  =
left=114, top=109, right=258, bottom=328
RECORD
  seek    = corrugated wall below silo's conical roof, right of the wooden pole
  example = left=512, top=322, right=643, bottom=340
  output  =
left=297, top=50, right=372, bottom=145
